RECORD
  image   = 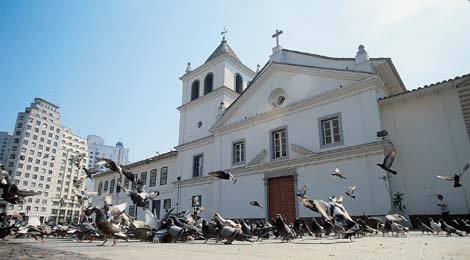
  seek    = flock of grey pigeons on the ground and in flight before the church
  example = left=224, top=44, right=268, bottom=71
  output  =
left=0, top=143, right=470, bottom=246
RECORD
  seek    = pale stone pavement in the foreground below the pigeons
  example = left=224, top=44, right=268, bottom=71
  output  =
left=0, top=232, right=470, bottom=260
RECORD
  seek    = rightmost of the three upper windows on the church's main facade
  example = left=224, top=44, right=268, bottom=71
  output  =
left=318, top=113, right=343, bottom=148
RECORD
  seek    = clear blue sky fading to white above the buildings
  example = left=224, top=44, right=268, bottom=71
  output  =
left=0, top=0, right=470, bottom=161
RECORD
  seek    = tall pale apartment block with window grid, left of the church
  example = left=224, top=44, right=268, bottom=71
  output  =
left=6, top=98, right=88, bottom=223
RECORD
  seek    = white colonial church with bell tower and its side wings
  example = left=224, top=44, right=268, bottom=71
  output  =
left=95, top=34, right=470, bottom=221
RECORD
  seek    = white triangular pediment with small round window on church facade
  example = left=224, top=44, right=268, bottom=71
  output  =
left=211, top=62, right=377, bottom=131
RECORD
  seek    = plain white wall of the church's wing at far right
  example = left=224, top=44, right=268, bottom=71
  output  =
left=382, top=88, right=470, bottom=214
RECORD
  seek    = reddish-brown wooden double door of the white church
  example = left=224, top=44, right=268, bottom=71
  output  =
left=268, top=175, right=296, bottom=224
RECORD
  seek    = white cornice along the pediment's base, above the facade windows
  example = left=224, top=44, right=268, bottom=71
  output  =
left=210, top=76, right=383, bottom=135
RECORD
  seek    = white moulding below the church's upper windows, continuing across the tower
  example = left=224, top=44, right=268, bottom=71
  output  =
left=173, top=141, right=383, bottom=187
